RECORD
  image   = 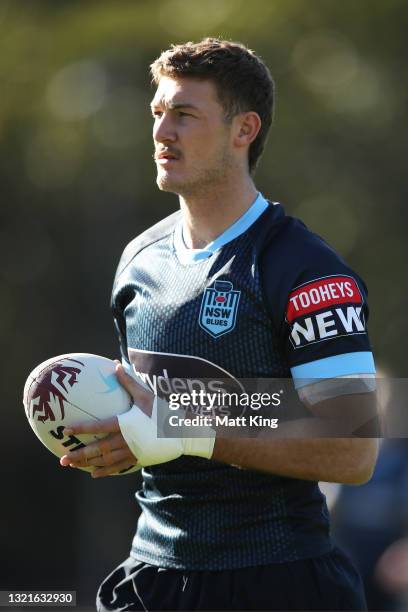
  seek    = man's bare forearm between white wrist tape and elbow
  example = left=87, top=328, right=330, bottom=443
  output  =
left=212, top=438, right=377, bottom=484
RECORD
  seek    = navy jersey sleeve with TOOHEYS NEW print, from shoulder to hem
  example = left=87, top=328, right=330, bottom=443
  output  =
left=262, top=220, right=375, bottom=403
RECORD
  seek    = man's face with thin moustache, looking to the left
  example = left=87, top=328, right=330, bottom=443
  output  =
left=151, top=77, right=234, bottom=196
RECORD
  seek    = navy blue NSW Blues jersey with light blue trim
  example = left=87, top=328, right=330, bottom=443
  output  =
left=112, top=196, right=373, bottom=570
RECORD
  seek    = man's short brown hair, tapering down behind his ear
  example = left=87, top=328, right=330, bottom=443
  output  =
left=150, top=38, right=275, bottom=173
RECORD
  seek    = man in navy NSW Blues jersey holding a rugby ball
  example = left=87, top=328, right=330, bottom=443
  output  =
left=61, top=39, right=376, bottom=610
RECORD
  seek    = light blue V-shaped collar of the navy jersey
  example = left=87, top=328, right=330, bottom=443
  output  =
left=174, top=193, right=269, bottom=265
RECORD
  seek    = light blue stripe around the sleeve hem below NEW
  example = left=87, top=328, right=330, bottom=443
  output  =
left=290, top=351, right=375, bottom=389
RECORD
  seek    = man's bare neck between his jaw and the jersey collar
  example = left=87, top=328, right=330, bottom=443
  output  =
left=180, top=176, right=257, bottom=249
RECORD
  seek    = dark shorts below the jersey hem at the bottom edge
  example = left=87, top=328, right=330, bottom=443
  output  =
left=96, top=549, right=367, bottom=612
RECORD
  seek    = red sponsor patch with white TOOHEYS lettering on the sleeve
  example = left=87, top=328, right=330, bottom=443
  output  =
left=286, top=276, right=363, bottom=323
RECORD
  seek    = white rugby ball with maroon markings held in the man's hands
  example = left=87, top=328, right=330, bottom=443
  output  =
left=23, top=353, right=140, bottom=475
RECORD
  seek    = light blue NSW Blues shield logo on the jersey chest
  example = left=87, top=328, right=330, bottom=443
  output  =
left=199, top=280, right=241, bottom=338
